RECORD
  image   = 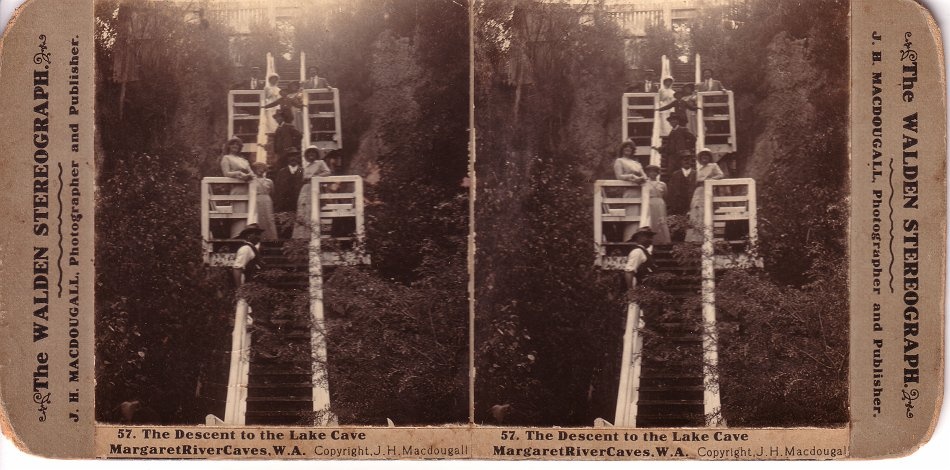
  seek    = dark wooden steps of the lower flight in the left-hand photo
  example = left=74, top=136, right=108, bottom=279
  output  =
left=245, top=241, right=314, bottom=425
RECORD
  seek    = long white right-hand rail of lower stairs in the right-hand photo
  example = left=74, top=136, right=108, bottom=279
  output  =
left=702, top=180, right=726, bottom=427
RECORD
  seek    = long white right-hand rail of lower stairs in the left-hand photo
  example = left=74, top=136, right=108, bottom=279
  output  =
left=308, top=176, right=336, bottom=425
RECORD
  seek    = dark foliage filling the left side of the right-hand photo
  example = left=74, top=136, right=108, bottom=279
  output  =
left=475, top=2, right=624, bottom=425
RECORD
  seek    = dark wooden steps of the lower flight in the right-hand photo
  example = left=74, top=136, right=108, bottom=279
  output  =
left=637, top=245, right=706, bottom=427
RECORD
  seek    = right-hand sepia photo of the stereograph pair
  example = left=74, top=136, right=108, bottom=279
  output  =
left=473, top=0, right=850, bottom=428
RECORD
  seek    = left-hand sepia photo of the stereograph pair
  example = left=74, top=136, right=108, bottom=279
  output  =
left=95, top=0, right=470, bottom=426
